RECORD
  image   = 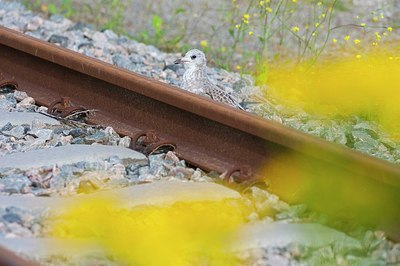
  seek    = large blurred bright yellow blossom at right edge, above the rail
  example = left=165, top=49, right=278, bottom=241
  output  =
left=257, top=47, right=400, bottom=139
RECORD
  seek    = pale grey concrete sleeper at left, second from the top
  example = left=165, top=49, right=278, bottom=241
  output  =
left=0, top=144, right=147, bottom=170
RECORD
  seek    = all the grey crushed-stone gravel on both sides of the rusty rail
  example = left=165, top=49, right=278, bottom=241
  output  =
left=0, top=0, right=400, bottom=265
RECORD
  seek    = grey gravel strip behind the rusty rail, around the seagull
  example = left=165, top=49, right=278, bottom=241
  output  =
left=0, top=1, right=400, bottom=163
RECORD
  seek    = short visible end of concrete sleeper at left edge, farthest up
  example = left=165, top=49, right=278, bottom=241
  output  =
left=0, top=111, right=60, bottom=128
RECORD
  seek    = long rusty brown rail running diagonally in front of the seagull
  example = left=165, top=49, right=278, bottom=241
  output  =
left=0, top=27, right=400, bottom=237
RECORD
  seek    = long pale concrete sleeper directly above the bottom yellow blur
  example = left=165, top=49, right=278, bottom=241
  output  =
left=0, top=181, right=241, bottom=214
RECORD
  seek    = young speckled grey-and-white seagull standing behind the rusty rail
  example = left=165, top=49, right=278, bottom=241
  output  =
left=175, top=49, right=244, bottom=110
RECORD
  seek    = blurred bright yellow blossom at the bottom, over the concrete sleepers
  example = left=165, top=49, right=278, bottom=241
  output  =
left=53, top=198, right=246, bottom=266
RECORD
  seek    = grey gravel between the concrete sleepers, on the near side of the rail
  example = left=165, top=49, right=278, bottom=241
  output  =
left=0, top=87, right=400, bottom=265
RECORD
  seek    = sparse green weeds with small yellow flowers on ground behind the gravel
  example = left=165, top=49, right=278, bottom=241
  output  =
left=22, top=0, right=396, bottom=72
